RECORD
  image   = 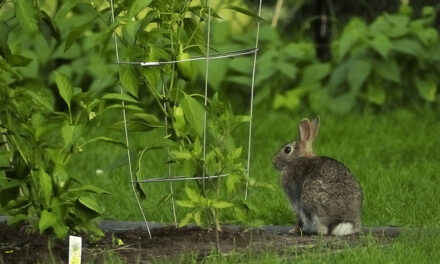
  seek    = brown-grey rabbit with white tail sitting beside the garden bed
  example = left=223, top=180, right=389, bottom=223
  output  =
left=273, top=116, right=363, bottom=236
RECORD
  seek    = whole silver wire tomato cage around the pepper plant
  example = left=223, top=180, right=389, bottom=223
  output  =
left=110, top=0, right=262, bottom=238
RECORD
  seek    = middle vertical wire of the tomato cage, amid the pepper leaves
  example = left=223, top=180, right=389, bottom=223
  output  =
left=202, top=0, right=211, bottom=193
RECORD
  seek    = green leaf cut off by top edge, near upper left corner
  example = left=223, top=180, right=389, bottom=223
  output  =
left=15, top=0, right=38, bottom=33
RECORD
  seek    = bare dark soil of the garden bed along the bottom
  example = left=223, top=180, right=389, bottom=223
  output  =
left=0, top=223, right=398, bottom=264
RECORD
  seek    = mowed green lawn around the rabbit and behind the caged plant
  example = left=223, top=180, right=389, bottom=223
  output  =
left=72, top=108, right=440, bottom=263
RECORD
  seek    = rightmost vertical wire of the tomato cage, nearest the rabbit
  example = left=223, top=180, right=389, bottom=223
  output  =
left=244, top=0, right=262, bottom=200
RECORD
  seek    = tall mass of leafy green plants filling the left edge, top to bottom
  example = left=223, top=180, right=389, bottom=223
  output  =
left=0, top=0, right=120, bottom=238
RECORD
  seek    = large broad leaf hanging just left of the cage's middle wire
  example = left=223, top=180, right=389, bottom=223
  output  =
left=182, top=93, right=205, bottom=137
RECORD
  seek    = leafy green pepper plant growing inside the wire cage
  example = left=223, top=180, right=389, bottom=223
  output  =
left=104, top=0, right=270, bottom=239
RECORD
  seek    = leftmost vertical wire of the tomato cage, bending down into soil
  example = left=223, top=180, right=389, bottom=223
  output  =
left=110, top=0, right=152, bottom=238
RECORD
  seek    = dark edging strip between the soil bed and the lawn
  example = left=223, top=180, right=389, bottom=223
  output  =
left=0, top=216, right=401, bottom=237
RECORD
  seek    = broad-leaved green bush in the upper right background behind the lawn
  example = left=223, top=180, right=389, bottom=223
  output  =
left=274, top=5, right=440, bottom=113
